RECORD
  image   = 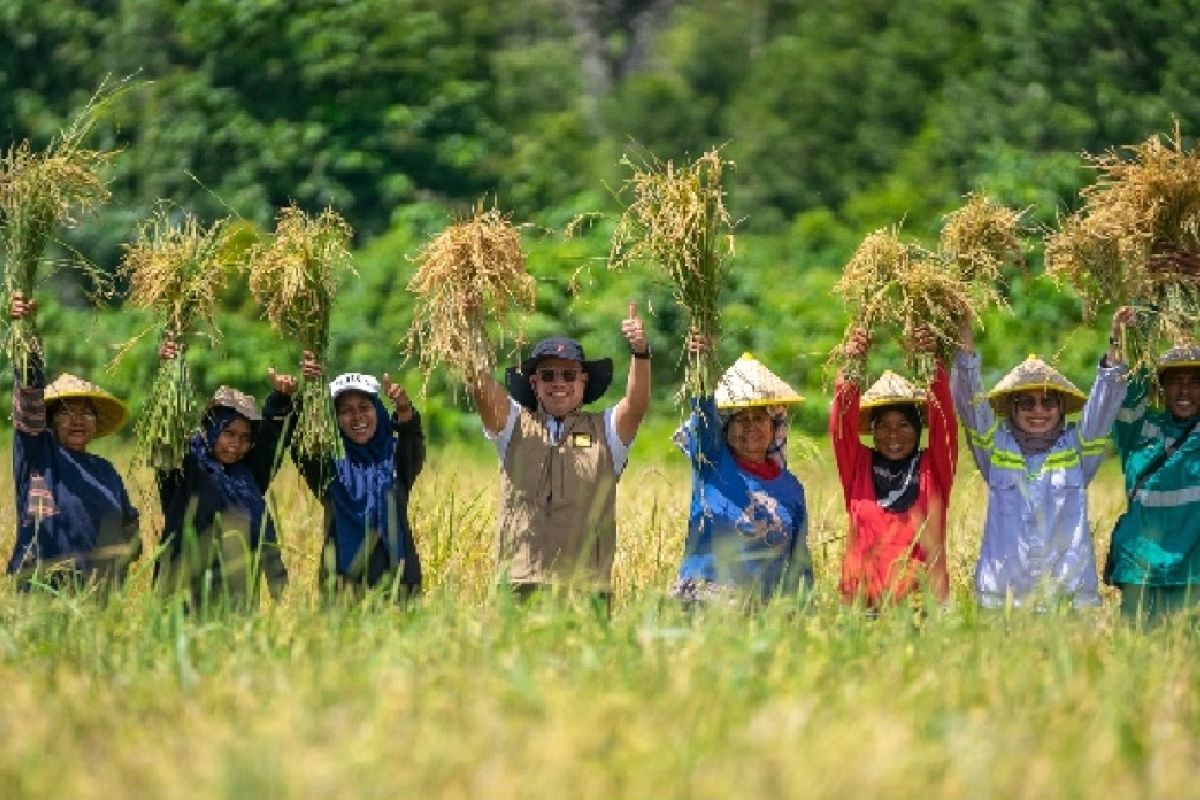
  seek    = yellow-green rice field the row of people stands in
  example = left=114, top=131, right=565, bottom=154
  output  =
left=0, top=441, right=1200, bottom=800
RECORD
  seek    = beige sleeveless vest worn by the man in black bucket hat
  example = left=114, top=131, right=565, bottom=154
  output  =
left=499, top=409, right=617, bottom=590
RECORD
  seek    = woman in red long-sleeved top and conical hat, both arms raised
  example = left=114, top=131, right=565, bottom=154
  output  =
left=829, top=327, right=959, bottom=608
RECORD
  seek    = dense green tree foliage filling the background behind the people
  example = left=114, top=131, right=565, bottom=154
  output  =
left=0, top=0, right=1200, bottom=433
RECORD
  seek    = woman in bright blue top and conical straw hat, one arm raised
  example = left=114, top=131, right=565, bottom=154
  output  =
left=671, top=333, right=812, bottom=604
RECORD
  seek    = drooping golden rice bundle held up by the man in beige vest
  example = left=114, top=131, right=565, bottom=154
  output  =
left=407, top=206, right=536, bottom=393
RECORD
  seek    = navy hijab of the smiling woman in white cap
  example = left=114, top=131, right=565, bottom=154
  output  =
left=329, top=390, right=404, bottom=575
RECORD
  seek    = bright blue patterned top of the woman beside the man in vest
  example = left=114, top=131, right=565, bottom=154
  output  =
left=679, top=397, right=812, bottom=599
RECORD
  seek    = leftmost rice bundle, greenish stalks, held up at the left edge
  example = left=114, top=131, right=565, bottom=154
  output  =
left=0, top=94, right=113, bottom=374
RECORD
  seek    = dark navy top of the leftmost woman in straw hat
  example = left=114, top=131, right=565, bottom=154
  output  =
left=8, top=357, right=138, bottom=573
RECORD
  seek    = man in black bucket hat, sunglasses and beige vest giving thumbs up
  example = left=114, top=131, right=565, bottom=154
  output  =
left=469, top=302, right=650, bottom=603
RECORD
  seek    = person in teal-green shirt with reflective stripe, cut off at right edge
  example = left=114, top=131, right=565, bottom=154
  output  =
left=1105, top=335, right=1200, bottom=618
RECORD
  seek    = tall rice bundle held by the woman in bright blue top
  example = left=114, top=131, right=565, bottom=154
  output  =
left=608, top=149, right=733, bottom=396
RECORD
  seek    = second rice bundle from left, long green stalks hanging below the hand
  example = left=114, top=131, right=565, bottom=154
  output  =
left=120, top=205, right=227, bottom=468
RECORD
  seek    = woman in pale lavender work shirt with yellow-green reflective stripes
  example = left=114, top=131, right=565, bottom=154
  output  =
left=950, top=311, right=1129, bottom=607
